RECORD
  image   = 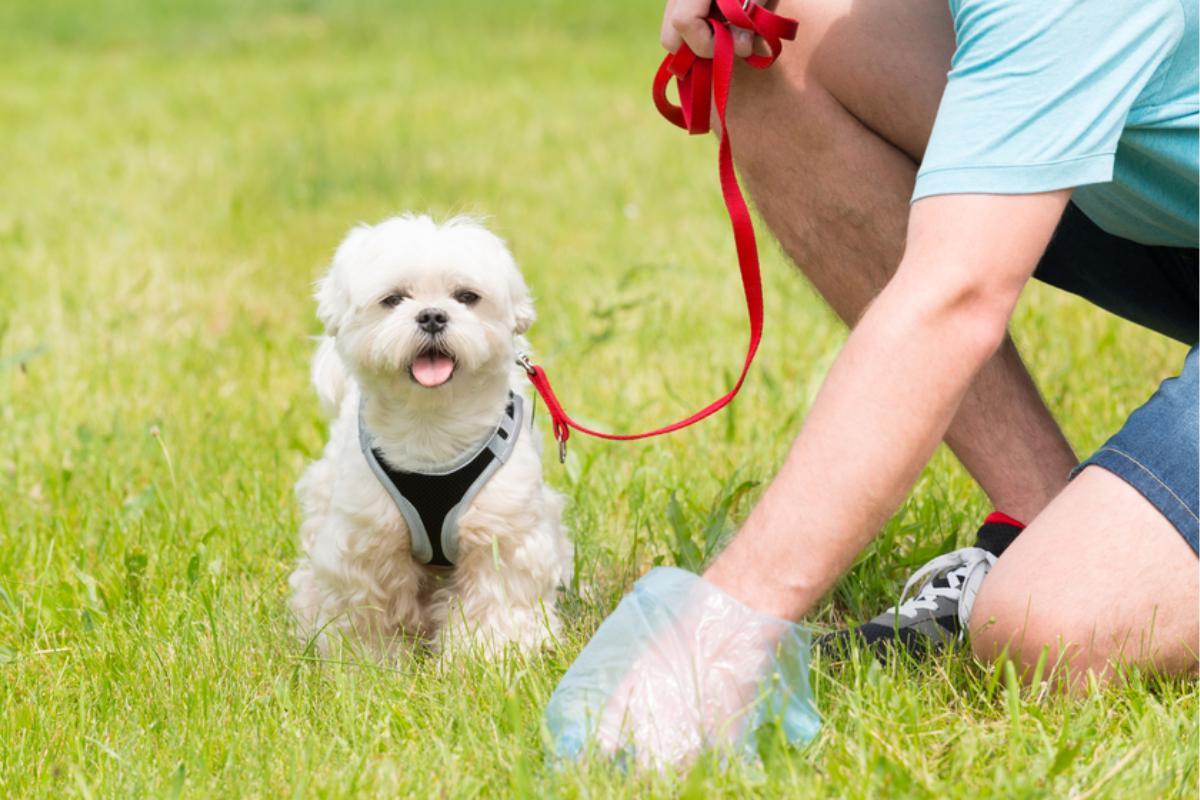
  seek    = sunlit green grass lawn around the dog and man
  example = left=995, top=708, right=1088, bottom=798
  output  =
left=0, top=0, right=1200, bottom=799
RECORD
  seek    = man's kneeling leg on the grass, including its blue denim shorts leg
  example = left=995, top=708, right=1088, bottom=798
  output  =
left=971, top=348, right=1200, bottom=680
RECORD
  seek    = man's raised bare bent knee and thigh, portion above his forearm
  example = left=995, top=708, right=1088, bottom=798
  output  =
left=728, top=0, right=954, bottom=309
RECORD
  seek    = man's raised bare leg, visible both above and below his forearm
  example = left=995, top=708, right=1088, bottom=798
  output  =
left=730, top=0, right=1075, bottom=521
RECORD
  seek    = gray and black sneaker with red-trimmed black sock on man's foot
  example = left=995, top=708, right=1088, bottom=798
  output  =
left=817, top=513, right=1024, bottom=656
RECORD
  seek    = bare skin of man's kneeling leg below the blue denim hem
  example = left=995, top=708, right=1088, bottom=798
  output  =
left=971, top=467, right=1200, bottom=682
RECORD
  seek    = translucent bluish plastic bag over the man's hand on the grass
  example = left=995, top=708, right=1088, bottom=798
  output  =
left=546, top=567, right=821, bottom=768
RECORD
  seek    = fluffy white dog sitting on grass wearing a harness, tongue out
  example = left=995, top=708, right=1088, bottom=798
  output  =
left=289, top=216, right=572, bottom=655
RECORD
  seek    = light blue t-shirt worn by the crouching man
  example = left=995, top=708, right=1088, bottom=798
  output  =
left=913, top=0, right=1200, bottom=247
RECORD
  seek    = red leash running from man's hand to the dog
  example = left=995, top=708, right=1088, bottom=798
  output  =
left=521, top=0, right=797, bottom=461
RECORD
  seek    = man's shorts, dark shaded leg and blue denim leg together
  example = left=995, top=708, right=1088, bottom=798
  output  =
left=1033, top=204, right=1200, bottom=553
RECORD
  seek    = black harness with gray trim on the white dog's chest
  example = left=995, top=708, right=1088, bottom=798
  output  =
left=359, top=391, right=524, bottom=567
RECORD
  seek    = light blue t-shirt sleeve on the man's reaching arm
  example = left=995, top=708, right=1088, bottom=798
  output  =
left=913, top=0, right=1183, bottom=200
